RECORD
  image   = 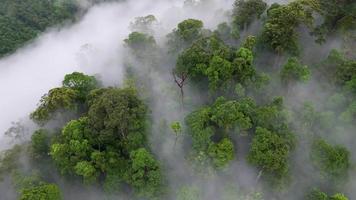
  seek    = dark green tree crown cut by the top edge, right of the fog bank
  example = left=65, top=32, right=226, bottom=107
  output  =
left=232, top=0, right=267, bottom=29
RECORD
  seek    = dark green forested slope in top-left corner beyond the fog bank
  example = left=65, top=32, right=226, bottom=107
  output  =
left=0, top=0, right=78, bottom=57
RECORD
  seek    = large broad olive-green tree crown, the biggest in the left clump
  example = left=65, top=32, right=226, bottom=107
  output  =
left=88, top=88, right=147, bottom=152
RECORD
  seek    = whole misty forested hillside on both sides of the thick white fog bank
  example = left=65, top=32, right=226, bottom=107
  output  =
left=0, top=0, right=356, bottom=200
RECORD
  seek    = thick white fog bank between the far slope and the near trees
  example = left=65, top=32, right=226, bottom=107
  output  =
left=0, top=0, right=236, bottom=144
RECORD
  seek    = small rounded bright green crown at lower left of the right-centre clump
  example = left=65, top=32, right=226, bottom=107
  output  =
left=208, top=138, right=235, bottom=169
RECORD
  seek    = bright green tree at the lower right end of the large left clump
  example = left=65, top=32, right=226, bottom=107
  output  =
left=126, top=148, right=163, bottom=199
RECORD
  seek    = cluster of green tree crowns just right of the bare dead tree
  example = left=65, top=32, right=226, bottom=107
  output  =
left=174, top=36, right=257, bottom=91
